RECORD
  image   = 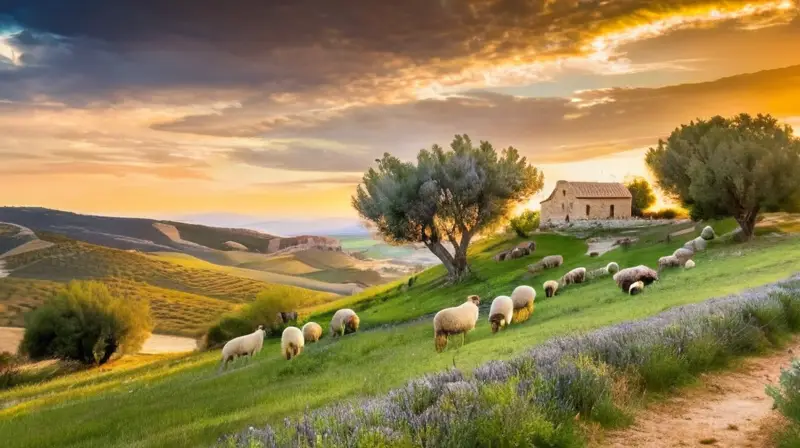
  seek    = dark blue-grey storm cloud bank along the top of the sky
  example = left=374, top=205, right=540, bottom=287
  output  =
left=0, top=0, right=780, bottom=104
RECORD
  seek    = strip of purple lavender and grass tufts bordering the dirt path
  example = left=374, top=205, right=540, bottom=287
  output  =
left=219, top=275, right=800, bottom=447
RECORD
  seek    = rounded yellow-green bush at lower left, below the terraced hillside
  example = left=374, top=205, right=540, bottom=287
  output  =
left=21, top=281, right=153, bottom=365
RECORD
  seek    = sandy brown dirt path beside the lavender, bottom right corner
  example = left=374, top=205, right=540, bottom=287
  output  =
left=593, top=341, right=800, bottom=448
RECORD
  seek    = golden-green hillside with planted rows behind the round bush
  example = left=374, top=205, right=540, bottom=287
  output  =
left=0, top=239, right=336, bottom=335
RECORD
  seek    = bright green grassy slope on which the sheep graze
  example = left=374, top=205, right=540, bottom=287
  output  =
left=0, top=222, right=800, bottom=446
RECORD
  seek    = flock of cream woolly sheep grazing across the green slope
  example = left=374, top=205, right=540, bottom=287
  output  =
left=220, top=226, right=716, bottom=370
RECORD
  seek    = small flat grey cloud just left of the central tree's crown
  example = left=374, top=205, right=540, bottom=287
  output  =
left=228, top=144, right=371, bottom=172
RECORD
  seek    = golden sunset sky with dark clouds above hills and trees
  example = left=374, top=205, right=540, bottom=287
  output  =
left=0, top=0, right=800, bottom=223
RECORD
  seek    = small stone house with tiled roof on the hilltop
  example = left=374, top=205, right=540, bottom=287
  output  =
left=540, top=180, right=633, bottom=226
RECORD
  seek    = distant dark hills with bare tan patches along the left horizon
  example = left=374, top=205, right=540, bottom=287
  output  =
left=0, top=207, right=389, bottom=295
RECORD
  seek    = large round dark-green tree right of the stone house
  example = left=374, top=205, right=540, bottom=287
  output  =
left=646, top=114, right=800, bottom=239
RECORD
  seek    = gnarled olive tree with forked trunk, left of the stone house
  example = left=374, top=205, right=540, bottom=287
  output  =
left=352, top=135, right=544, bottom=280
